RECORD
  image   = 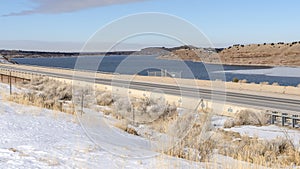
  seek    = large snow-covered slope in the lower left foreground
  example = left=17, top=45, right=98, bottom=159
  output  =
left=0, top=84, right=211, bottom=169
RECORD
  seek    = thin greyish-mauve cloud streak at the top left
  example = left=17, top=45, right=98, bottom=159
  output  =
left=3, top=0, right=145, bottom=16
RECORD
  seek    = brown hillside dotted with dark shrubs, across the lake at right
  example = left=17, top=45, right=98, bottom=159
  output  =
left=159, top=42, right=300, bottom=66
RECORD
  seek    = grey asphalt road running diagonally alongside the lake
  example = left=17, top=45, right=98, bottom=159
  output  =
left=0, top=65, right=300, bottom=115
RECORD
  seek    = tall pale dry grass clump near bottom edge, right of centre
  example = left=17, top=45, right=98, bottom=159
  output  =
left=165, top=113, right=217, bottom=162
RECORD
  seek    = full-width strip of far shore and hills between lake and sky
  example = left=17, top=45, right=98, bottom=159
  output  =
left=0, top=41, right=300, bottom=67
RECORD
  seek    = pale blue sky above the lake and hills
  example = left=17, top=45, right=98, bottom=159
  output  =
left=0, top=0, right=300, bottom=51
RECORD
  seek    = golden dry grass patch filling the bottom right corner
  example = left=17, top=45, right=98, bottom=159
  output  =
left=217, top=131, right=300, bottom=167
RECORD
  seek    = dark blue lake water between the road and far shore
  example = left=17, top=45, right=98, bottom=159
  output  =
left=13, top=56, right=300, bottom=86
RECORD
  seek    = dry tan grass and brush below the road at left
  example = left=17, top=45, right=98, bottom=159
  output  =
left=6, top=77, right=119, bottom=114
